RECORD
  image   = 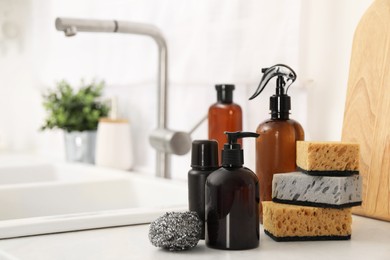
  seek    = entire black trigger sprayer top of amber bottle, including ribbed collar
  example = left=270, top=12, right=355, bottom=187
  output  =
left=249, top=64, right=297, bottom=119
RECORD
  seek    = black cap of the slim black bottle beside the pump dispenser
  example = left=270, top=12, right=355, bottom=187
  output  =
left=191, top=140, right=219, bottom=168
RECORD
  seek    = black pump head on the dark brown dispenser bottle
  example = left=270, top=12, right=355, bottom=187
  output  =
left=222, top=132, right=259, bottom=167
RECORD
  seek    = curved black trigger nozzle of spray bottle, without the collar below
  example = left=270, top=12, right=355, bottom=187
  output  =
left=249, top=64, right=297, bottom=100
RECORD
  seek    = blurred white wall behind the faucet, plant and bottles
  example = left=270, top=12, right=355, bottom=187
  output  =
left=0, top=0, right=372, bottom=179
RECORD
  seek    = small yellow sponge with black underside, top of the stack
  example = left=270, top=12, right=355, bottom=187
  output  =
left=297, top=141, right=359, bottom=176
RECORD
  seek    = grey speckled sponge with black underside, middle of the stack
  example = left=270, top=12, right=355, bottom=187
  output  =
left=272, top=172, right=362, bottom=208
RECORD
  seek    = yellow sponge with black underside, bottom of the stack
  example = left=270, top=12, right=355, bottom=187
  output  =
left=262, top=201, right=352, bottom=241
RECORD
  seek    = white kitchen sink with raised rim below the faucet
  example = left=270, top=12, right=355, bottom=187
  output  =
left=0, top=157, right=188, bottom=238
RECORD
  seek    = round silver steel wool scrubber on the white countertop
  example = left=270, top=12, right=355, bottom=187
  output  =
left=149, top=211, right=202, bottom=251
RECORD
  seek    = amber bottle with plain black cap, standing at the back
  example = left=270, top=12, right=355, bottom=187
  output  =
left=208, top=84, right=242, bottom=165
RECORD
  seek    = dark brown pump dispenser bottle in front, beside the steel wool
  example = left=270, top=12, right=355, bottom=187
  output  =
left=206, top=132, right=259, bottom=250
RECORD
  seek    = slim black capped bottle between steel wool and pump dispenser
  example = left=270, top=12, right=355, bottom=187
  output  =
left=188, top=140, right=219, bottom=239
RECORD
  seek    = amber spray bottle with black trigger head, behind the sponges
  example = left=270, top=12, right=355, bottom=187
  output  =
left=249, top=64, right=304, bottom=223
